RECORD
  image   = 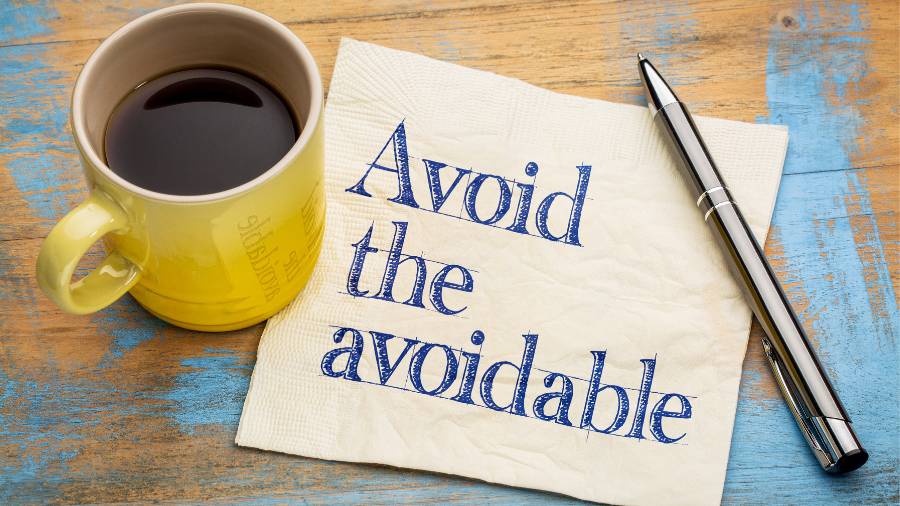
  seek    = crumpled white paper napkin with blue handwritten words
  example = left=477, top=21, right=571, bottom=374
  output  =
left=236, top=39, right=787, bottom=504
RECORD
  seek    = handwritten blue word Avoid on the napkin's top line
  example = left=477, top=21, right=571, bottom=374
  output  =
left=345, top=122, right=591, bottom=246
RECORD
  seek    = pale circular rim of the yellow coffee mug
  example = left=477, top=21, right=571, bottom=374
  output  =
left=72, top=3, right=324, bottom=203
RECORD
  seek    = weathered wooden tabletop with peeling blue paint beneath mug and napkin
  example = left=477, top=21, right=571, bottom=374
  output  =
left=0, top=0, right=900, bottom=504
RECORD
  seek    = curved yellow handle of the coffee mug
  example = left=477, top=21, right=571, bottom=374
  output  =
left=37, top=190, right=141, bottom=314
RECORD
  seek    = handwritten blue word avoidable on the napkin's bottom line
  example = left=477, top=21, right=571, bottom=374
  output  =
left=321, top=327, right=692, bottom=443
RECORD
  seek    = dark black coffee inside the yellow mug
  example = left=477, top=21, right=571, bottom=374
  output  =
left=104, top=69, right=300, bottom=195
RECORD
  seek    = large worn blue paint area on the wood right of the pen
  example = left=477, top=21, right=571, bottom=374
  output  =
left=726, top=4, right=900, bottom=503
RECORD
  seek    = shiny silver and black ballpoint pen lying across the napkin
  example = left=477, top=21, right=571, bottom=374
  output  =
left=638, top=53, right=869, bottom=473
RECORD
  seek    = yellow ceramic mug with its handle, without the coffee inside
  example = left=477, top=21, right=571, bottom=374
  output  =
left=37, top=4, right=325, bottom=331
